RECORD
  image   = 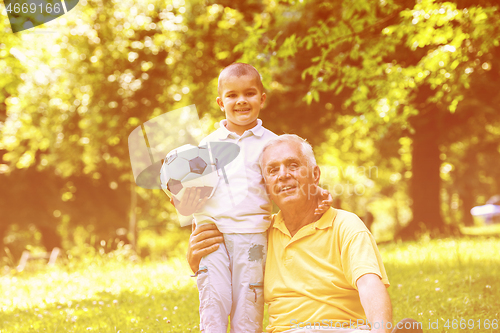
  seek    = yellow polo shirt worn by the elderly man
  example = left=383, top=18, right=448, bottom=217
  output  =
left=264, top=208, right=389, bottom=332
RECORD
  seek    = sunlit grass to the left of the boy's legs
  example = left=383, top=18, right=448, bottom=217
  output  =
left=0, top=244, right=199, bottom=333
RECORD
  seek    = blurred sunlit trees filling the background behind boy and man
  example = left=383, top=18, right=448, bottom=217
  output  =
left=0, top=0, right=500, bottom=258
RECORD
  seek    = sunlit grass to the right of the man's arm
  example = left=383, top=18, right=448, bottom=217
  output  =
left=381, top=238, right=500, bottom=332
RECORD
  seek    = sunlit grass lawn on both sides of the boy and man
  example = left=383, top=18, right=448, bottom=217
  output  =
left=0, top=238, right=500, bottom=333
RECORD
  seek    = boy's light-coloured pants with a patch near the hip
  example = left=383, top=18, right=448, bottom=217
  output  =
left=196, top=232, right=267, bottom=333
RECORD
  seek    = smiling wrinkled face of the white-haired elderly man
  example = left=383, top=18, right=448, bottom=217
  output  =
left=262, top=142, right=320, bottom=209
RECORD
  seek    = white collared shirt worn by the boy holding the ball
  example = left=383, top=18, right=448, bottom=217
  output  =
left=194, top=119, right=277, bottom=233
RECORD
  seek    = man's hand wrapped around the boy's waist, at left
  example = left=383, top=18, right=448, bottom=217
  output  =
left=186, top=222, right=224, bottom=273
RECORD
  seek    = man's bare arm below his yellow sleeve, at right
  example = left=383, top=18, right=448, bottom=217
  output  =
left=356, top=274, right=392, bottom=333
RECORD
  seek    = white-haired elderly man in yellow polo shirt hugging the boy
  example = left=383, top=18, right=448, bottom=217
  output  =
left=188, top=134, right=422, bottom=333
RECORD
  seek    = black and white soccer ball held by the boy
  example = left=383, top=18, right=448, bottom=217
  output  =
left=160, top=145, right=219, bottom=200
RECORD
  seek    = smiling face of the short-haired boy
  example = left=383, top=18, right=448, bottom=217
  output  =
left=217, top=75, right=266, bottom=135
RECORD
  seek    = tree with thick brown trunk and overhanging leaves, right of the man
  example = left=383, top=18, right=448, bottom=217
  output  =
left=236, top=0, right=500, bottom=237
